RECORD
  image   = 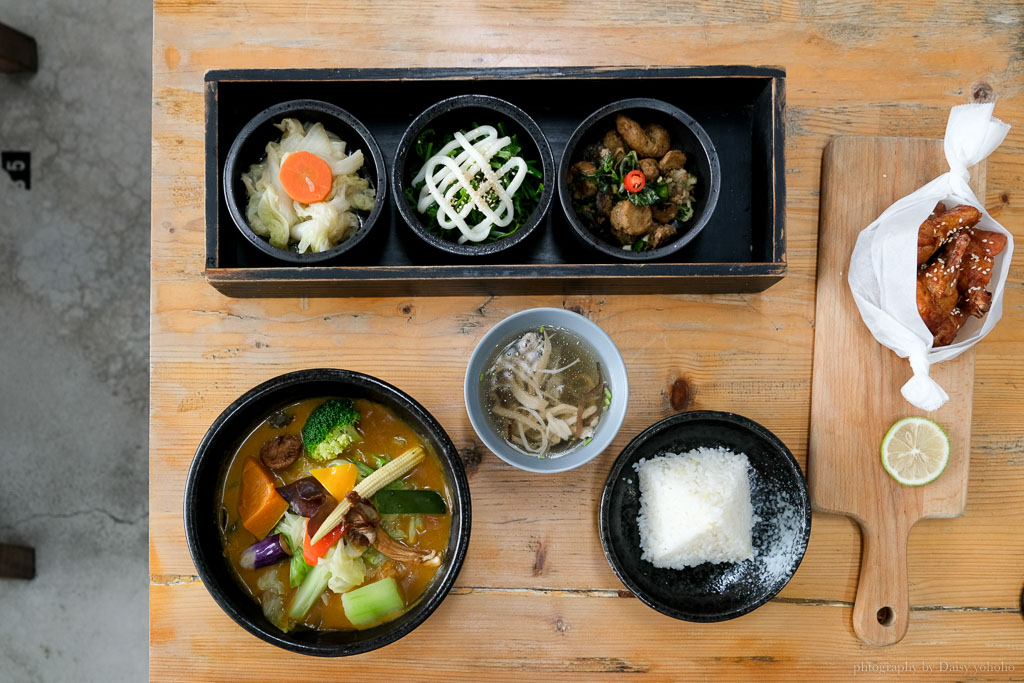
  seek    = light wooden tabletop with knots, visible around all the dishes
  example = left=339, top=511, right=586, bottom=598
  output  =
left=150, top=0, right=1024, bottom=681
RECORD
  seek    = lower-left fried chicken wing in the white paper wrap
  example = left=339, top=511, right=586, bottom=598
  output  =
left=918, top=230, right=971, bottom=346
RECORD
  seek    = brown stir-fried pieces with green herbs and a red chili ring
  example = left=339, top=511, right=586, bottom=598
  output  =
left=565, top=115, right=697, bottom=252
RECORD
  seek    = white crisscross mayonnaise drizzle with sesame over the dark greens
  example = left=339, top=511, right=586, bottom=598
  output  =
left=413, top=126, right=526, bottom=244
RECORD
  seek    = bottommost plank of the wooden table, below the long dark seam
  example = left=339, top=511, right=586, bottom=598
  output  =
left=151, top=584, right=1021, bottom=683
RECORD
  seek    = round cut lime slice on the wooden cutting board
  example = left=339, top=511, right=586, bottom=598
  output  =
left=882, top=418, right=949, bottom=486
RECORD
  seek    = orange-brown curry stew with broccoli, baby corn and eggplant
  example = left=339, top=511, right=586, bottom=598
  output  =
left=219, top=397, right=452, bottom=632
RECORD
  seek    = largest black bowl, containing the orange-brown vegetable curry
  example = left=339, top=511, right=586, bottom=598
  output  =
left=184, top=370, right=471, bottom=656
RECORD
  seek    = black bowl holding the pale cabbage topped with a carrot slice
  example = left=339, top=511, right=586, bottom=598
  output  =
left=223, top=99, right=387, bottom=264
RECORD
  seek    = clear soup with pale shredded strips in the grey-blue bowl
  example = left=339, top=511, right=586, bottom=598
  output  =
left=480, top=326, right=611, bottom=458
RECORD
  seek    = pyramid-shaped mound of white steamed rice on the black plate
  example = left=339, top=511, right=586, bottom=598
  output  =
left=633, top=447, right=754, bottom=569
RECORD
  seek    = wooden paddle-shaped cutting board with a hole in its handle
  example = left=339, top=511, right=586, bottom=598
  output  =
left=808, top=137, right=985, bottom=645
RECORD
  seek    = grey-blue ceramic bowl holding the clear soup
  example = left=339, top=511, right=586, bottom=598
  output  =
left=465, top=308, right=630, bottom=472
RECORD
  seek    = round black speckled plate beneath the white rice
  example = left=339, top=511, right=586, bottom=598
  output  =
left=600, top=411, right=811, bottom=622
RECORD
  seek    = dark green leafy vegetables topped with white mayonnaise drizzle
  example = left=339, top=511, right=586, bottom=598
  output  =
left=406, top=122, right=544, bottom=244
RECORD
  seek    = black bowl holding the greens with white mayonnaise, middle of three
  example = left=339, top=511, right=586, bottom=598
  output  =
left=391, top=95, right=555, bottom=256
